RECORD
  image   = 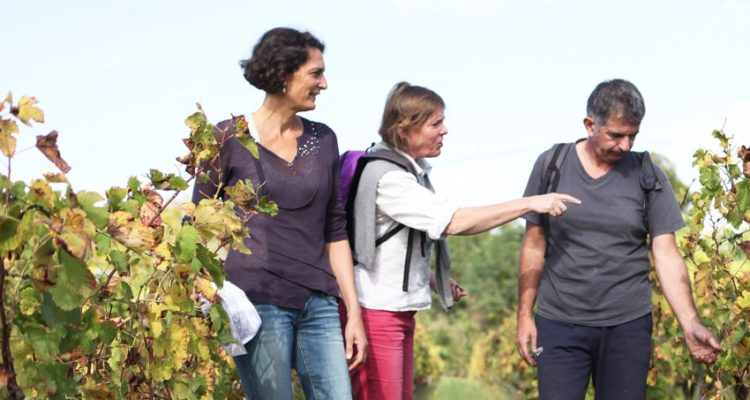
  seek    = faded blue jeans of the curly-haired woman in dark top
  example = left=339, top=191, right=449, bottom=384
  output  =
left=234, top=294, right=352, bottom=400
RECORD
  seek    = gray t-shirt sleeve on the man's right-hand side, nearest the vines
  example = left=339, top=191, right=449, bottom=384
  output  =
left=648, top=164, right=685, bottom=237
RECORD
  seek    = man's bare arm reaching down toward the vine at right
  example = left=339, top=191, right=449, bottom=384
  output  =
left=652, top=233, right=721, bottom=363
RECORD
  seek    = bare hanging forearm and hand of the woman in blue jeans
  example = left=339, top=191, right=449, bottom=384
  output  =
left=326, top=240, right=367, bottom=371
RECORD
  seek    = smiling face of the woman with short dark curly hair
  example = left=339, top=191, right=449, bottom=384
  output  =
left=284, top=48, right=328, bottom=112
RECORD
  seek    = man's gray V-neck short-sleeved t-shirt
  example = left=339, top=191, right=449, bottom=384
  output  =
left=523, top=143, right=685, bottom=326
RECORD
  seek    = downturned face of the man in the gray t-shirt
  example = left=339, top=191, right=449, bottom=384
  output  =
left=583, top=113, right=640, bottom=165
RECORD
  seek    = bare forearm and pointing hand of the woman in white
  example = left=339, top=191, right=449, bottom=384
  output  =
left=445, top=193, right=581, bottom=235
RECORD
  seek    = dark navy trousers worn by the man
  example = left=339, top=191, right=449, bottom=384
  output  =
left=535, top=313, right=653, bottom=400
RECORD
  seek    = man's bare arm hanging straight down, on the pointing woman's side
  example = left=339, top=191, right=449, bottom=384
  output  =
left=516, top=222, right=547, bottom=365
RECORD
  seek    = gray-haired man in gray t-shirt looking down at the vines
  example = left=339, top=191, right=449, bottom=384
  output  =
left=517, top=79, right=719, bottom=399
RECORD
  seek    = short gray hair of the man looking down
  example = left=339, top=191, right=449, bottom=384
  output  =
left=586, top=79, right=646, bottom=125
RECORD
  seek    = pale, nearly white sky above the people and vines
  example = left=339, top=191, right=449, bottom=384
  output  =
left=0, top=0, right=750, bottom=206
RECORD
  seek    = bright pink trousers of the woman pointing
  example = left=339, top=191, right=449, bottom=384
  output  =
left=341, top=303, right=416, bottom=400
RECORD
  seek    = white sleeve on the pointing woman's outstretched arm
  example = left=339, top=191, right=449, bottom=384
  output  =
left=375, top=171, right=457, bottom=240
